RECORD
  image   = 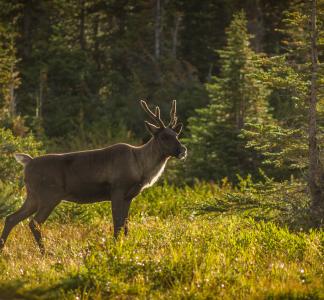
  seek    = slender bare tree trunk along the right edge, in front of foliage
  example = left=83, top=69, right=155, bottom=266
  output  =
left=308, top=0, right=324, bottom=225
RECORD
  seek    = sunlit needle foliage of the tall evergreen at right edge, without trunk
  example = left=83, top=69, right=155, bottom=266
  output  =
left=244, top=3, right=324, bottom=175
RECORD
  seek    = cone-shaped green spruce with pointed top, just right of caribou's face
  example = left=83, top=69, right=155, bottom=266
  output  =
left=187, top=11, right=271, bottom=179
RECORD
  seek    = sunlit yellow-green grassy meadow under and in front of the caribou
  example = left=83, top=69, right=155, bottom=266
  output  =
left=0, top=184, right=324, bottom=299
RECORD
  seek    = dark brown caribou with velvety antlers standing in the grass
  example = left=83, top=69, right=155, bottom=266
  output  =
left=0, top=100, right=187, bottom=253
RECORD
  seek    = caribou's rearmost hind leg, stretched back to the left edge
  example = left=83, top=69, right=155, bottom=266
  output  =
left=0, top=196, right=37, bottom=251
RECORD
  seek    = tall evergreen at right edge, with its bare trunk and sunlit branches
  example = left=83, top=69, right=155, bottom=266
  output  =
left=244, top=0, right=324, bottom=224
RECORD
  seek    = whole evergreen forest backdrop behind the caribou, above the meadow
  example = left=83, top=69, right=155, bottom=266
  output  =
left=0, top=0, right=324, bottom=220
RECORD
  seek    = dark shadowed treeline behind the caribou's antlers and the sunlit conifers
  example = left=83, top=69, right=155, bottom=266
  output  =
left=0, top=0, right=291, bottom=137
